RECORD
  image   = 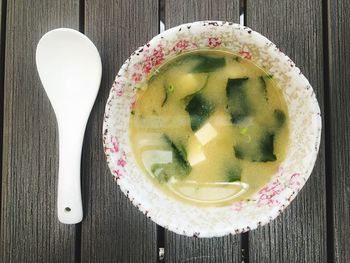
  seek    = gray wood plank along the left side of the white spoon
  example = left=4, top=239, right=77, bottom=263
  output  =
left=0, top=0, right=79, bottom=262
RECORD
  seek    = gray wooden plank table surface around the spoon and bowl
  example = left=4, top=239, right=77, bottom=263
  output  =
left=0, top=0, right=350, bottom=263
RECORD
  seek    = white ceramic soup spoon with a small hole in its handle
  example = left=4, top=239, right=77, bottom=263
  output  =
left=36, top=28, right=102, bottom=224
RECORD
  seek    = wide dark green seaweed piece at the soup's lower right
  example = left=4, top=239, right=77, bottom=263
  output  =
left=234, top=132, right=276, bottom=162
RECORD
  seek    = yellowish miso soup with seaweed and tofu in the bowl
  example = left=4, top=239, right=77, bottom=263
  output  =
left=129, top=49, right=288, bottom=206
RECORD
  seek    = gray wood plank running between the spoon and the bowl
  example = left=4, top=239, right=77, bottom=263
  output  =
left=81, top=0, right=159, bottom=262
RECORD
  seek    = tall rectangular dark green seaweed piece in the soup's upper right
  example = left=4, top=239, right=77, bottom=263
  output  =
left=226, top=78, right=251, bottom=124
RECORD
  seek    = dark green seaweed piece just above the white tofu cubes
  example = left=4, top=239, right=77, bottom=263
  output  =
left=185, top=93, right=214, bottom=132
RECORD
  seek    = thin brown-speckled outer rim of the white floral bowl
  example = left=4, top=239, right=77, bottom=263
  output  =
left=102, top=21, right=322, bottom=237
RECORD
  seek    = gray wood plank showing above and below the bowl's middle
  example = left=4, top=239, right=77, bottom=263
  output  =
left=165, top=0, right=242, bottom=263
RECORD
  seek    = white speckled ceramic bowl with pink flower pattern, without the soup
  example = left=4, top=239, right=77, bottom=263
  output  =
left=103, top=21, right=321, bottom=237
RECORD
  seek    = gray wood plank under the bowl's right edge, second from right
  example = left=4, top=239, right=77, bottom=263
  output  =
left=247, top=0, right=327, bottom=262
